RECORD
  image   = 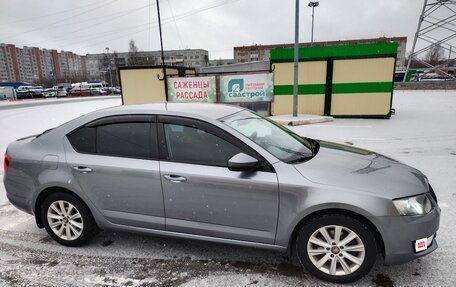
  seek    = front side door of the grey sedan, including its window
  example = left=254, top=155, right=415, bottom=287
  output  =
left=158, top=116, right=279, bottom=244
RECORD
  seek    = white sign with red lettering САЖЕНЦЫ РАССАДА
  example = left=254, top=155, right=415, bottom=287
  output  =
left=168, top=76, right=216, bottom=103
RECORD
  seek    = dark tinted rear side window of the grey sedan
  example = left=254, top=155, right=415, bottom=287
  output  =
left=68, top=122, right=158, bottom=159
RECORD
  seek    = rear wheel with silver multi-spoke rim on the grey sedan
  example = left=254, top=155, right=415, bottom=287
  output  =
left=41, top=192, right=97, bottom=247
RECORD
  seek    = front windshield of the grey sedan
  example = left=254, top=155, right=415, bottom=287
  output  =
left=220, top=110, right=314, bottom=163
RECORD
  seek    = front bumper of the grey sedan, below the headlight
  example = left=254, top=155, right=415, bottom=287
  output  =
left=377, top=205, right=441, bottom=265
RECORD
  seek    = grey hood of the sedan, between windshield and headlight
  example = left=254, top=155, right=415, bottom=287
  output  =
left=295, top=141, right=427, bottom=198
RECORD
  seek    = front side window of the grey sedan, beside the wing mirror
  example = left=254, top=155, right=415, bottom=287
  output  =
left=163, top=123, right=242, bottom=167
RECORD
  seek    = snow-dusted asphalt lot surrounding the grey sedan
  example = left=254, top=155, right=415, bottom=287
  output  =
left=0, top=91, right=456, bottom=286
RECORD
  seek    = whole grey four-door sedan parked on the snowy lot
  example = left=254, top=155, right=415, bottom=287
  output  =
left=4, top=103, right=440, bottom=282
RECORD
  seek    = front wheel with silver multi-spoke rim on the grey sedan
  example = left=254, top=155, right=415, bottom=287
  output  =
left=296, top=214, right=377, bottom=283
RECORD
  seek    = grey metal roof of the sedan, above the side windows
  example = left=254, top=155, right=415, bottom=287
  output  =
left=100, top=103, right=244, bottom=119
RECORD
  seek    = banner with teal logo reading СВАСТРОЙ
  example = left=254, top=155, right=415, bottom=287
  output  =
left=220, top=73, right=274, bottom=103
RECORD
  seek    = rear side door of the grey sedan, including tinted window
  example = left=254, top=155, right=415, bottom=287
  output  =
left=65, top=115, right=165, bottom=229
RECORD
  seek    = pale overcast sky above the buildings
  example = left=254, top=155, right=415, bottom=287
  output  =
left=0, top=0, right=456, bottom=59
